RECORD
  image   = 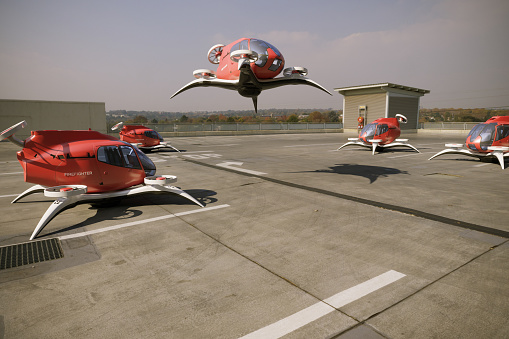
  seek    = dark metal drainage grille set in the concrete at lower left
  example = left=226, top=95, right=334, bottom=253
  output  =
left=0, top=238, right=64, bottom=270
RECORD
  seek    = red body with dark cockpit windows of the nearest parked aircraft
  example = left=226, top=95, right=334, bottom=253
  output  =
left=17, top=130, right=155, bottom=193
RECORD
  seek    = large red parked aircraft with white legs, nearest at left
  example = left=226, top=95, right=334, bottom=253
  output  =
left=0, top=121, right=203, bottom=240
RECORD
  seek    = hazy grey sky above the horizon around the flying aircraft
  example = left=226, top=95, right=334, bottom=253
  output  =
left=0, top=0, right=509, bottom=112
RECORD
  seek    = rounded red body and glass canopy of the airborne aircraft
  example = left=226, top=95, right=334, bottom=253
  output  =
left=216, top=38, right=285, bottom=80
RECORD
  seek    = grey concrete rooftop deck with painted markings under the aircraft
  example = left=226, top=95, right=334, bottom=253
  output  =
left=0, top=133, right=509, bottom=339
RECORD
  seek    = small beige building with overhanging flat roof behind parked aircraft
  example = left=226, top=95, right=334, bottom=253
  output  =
left=334, top=83, right=429, bottom=130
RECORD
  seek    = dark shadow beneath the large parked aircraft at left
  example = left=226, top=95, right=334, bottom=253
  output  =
left=42, top=189, right=217, bottom=236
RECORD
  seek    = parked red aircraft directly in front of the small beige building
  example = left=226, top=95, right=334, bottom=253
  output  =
left=337, top=114, right=420, bottom=154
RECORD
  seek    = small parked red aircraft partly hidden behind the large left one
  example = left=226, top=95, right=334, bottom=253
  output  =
left=111, top=122, right=180, bottom=152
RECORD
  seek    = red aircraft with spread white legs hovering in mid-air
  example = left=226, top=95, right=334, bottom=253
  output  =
left=170, top=38, right=332, bottom=112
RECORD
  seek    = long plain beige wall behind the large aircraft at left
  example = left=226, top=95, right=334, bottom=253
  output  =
left=0, top=99, right=106, bottom=139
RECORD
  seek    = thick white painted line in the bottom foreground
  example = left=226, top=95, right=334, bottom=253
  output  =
left=239, top=270, right=405, bottom=339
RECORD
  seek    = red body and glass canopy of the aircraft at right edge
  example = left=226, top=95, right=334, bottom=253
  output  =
left=465, top=116, right=509, bottom=153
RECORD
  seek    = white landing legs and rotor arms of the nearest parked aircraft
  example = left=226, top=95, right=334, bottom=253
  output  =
left=12, top=175, right=204, bottom=240
